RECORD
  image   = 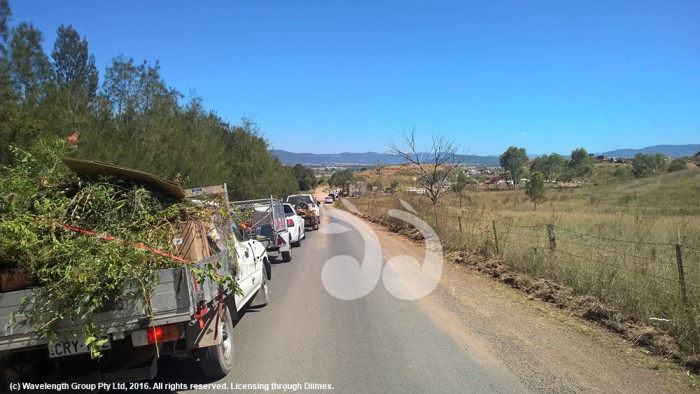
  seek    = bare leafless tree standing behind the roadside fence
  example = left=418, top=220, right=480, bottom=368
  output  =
left=389, top=129, right=464, bottom=205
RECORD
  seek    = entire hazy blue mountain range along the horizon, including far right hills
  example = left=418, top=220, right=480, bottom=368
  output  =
left=270, top=144, right=700, bottom=167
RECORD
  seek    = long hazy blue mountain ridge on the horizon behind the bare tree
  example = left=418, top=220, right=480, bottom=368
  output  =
left=270, top=149, right=498, bottom=167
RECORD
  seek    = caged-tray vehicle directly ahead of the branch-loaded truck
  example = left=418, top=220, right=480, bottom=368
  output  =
left=232, top=196, right=292, bottom=263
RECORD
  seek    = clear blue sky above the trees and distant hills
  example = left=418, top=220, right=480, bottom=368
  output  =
left=10, top=0, right=700, bottom=155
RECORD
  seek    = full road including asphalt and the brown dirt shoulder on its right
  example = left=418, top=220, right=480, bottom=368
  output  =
left=156, top=202, right=689, bottom=393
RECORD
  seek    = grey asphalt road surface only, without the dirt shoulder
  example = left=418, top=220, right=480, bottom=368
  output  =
left=151, top=206, right=527, bottom=393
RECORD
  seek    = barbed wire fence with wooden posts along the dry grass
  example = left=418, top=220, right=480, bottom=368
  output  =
left=431, top=212, right=700, bottom=324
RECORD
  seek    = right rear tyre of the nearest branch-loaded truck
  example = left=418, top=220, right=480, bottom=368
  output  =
left=199, top=305, right=233, bottom=378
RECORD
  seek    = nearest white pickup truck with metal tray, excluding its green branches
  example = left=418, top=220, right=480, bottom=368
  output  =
left=0, top=159, right=271, bottom=390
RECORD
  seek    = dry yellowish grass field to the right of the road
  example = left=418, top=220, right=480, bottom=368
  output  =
left=348, top=169, right=700, bottom=370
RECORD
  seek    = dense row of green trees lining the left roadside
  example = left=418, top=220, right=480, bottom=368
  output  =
left=0, top=1, right=306, bottom=199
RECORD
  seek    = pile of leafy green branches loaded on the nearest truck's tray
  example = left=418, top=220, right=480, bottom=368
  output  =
left=0, top=141, right=206, bottom=344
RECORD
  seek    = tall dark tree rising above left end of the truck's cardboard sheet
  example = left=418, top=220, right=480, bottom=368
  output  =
left=51, top=25, right=99, bottom=131
